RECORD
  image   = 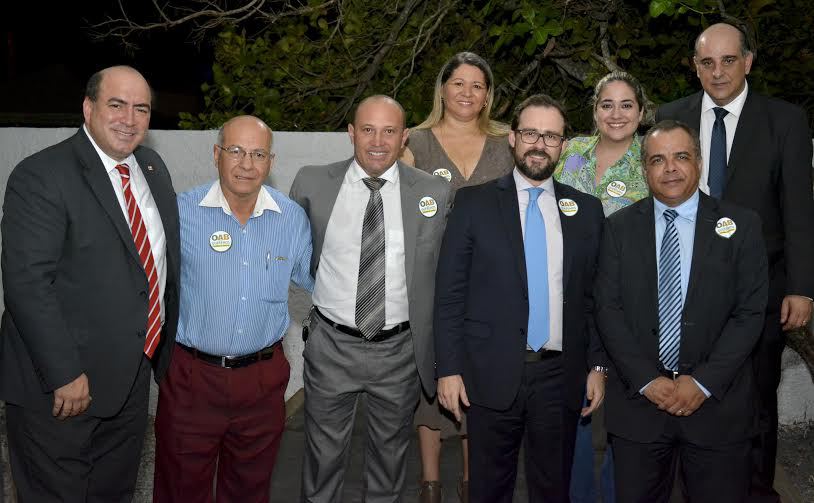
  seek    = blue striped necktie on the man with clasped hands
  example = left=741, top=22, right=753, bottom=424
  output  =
left=659, top=210, right=684, bottom=370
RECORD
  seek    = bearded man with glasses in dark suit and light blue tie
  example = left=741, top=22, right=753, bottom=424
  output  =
left=440, top=95, right=606, bottom=503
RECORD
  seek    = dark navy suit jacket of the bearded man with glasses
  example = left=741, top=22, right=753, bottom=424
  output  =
left=433, top=173, right=605, bottom=410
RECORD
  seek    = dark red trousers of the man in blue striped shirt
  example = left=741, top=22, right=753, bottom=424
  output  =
left=153, top=346, right=290, bottom=503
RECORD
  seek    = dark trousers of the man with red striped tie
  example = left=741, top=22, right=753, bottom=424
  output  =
left=6, top=357, right=151, bottom=503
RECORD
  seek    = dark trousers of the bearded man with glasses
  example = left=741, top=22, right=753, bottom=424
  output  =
left=467, top=356, right=579, bottom=503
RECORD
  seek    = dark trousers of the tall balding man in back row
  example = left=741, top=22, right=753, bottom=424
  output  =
left=748, top=313, right=785, bottom=503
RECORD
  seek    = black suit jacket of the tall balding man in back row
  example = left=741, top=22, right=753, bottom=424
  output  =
left=656, top=89, right=814, bottom=312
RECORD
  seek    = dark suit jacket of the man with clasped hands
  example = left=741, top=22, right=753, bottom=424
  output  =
left=596, top=194, right=768, bottom=445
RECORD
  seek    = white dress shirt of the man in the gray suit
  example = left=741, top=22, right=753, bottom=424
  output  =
left=313, top=159, right=410, bottom=330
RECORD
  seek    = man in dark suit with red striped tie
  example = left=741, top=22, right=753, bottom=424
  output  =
left=0, top=67, right=179, bottom=502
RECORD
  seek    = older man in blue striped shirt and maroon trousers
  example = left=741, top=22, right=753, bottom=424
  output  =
left=153, top=116, right=314, bottom=502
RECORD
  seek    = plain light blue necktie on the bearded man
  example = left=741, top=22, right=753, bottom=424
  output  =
left=523, top=187, right=549, bottom=351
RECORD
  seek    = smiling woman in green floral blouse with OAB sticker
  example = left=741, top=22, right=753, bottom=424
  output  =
left=554, top=71, right=648, bottom=216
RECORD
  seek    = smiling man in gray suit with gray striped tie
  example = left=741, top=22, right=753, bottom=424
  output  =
left=291, top=96, right=449, bottom=503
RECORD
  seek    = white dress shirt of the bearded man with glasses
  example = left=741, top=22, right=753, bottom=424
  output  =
left=512, top=168, right=563, bottom=351
